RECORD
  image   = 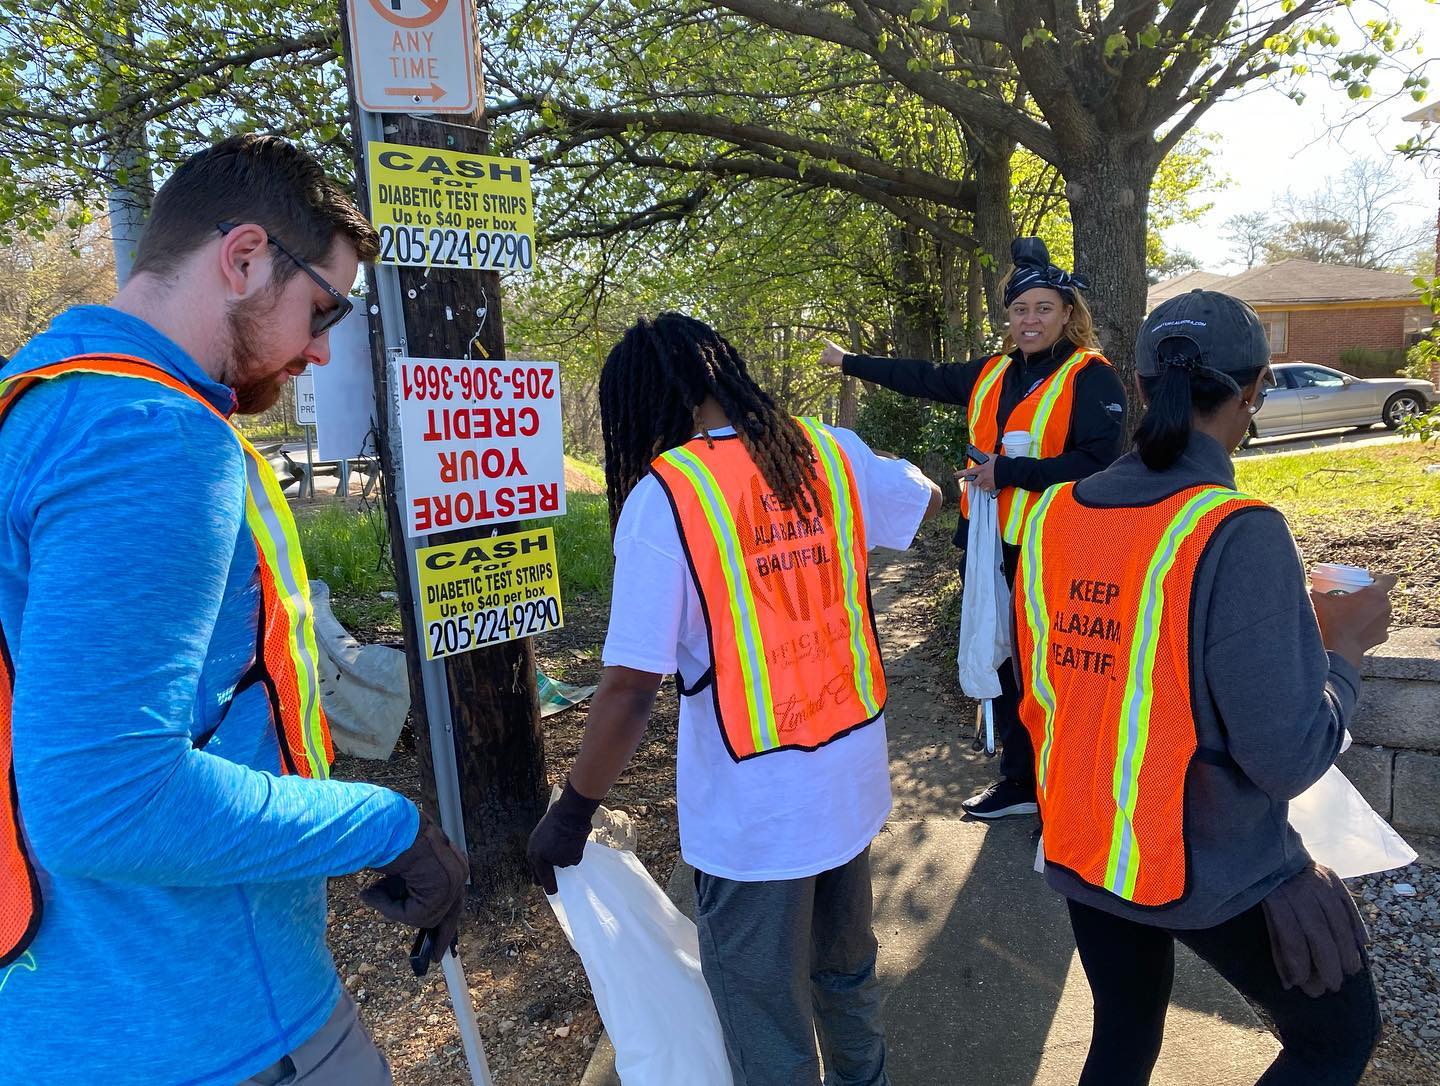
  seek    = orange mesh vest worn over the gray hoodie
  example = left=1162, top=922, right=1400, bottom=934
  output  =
left=1015, top=483, right=1267, bottom=909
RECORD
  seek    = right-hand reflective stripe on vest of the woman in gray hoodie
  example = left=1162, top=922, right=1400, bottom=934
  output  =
left=1104, top=487, right=1246, bottom=900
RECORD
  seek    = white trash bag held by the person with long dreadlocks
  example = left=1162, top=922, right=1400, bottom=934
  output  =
left=547, top=841, right=732, bottom=1086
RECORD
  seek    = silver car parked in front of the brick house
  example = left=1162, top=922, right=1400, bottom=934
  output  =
left=1247, top=362, right=1440, bottom=441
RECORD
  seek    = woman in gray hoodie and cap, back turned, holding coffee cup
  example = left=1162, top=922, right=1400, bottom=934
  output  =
left=1015, top=291, right=1395, bottom=1086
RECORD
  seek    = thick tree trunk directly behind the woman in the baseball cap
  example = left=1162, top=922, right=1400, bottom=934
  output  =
left=1063, top=144, right=1155, bottom=389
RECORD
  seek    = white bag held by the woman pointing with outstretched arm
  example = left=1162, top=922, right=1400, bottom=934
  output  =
left=958, top=487, right=1011, bottom=699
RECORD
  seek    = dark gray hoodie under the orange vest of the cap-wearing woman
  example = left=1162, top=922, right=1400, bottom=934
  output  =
left=1045, top=434, right=1359, bottom=929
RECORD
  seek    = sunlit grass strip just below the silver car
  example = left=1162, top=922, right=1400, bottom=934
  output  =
left=1236, top=441, right=1440, bottom=517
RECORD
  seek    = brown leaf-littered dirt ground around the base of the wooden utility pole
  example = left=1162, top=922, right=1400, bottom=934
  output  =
left=330, top=584, right=680, bottom=1086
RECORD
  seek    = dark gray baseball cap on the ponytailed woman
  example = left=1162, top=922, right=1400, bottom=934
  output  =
left=1135, top=290, right=1270, bottom=377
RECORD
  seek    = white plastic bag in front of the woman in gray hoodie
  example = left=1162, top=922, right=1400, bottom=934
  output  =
left=1290, top=766, right=1416, bottom=879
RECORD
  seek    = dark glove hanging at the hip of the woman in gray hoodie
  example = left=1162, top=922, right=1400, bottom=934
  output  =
left=1260, top=863, right=1367, bottom=998
